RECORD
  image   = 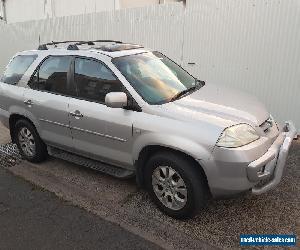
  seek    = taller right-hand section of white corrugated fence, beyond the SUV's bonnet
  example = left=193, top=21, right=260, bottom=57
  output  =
left=183, top=0, right=300, bottom=131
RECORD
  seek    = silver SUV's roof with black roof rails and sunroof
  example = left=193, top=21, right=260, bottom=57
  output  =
left=18, top=42, right=152, bottom=58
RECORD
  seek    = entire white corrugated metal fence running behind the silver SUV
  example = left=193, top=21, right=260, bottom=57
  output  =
left=0, top=0, right=300, bottom=132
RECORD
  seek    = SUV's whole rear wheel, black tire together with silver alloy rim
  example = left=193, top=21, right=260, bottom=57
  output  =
left=13, top=119, right=48, bottom=163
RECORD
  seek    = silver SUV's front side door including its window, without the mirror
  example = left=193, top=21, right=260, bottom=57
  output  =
left=69, top=58, right=134, bottom=167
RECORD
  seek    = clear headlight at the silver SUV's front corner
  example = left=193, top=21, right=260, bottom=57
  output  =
left=217, top=124, right=259, bottom=148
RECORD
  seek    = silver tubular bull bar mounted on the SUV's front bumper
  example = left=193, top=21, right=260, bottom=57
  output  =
left=247, top=122, right=297, bottom=195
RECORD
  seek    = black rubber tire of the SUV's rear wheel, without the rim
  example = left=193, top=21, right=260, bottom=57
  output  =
left=14, top=120, right=47, bottom=163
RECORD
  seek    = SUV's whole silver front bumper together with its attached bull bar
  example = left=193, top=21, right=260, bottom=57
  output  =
left=199, top=122, right=296, bottom=198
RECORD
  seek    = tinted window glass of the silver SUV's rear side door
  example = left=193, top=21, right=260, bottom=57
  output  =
left=29, top=56, right=72, bottom=95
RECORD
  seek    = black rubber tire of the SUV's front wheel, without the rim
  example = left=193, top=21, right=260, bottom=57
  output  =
left=144, top=152, right=206, bottom=219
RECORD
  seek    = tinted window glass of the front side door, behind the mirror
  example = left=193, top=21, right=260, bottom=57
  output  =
left=75, top=58, right=124, bottom=103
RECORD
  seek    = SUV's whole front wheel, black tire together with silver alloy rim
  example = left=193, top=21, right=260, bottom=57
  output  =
left=144, top=151, right=208, bottom=219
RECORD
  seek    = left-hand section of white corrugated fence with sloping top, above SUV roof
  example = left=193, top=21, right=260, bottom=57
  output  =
left=0, top=3, right=184, bottom=74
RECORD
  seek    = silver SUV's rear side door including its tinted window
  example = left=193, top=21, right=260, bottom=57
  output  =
left=23, top=56, right=74, bottom=149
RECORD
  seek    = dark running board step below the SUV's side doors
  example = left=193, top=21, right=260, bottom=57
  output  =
left=48, top=147, right=135, bottom=179
